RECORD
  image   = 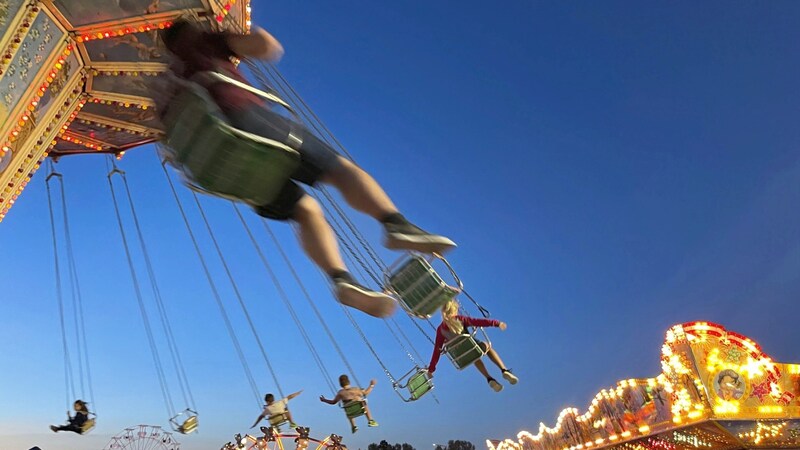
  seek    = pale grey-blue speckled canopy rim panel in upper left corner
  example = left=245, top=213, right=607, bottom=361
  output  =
left=0, top=12, right=65, bottom=117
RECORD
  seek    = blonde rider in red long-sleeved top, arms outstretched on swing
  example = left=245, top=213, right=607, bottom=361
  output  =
left=428, top=300, right=519, bottom=392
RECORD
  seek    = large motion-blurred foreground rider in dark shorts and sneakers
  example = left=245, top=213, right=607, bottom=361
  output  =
left=161, top=20, right=455, bottom=317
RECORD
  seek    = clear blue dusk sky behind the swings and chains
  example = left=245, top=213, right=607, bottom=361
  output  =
left=0, top=0, right=800, bottom=450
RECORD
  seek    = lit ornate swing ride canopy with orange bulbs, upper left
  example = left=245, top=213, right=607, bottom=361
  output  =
left=0, top=0, right=250, bottom=221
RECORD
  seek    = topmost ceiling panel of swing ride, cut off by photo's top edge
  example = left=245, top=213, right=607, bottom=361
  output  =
left=53, top=0, right=203, bottom=27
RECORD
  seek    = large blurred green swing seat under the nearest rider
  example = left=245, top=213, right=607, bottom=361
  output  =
left=162, top=81, right=300, bottom=205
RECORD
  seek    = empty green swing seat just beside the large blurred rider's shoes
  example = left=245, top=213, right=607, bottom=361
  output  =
left=386, top=254, right=461, bottom=319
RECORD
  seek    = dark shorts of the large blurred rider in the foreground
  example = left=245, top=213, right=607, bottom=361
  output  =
left=227, top=107, right=340, bottom=220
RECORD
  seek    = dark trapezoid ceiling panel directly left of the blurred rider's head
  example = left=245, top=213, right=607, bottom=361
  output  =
left=84, top=31, right=170, bottom=64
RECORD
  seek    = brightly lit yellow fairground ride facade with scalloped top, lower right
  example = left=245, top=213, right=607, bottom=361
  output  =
left=487, top=322, right=800, bottom=450
